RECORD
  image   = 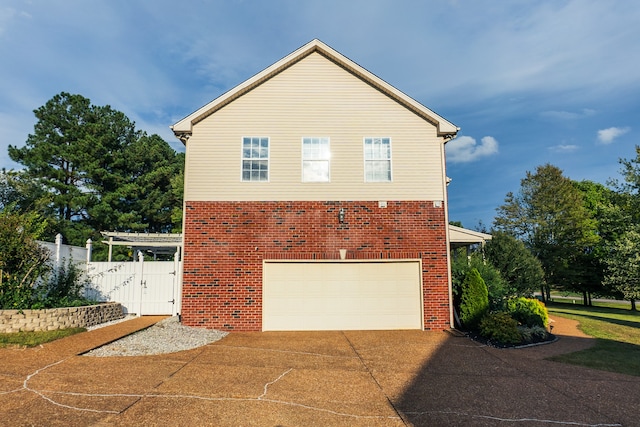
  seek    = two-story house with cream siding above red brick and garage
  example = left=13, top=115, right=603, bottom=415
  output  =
left=172, top=40, right=458, bottom=331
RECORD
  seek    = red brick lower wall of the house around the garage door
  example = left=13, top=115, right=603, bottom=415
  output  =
left=181, top=201, right=450, bottom=331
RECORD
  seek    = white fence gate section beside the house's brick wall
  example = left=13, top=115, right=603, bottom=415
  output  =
left=85, top=253, right=181, bottom=316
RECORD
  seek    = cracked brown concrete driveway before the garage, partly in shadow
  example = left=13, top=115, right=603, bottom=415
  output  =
left=0, top=320, right=640, bottom=427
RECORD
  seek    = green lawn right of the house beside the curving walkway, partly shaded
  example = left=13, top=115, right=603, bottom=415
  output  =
left=547, top=302, right=640, bottom=376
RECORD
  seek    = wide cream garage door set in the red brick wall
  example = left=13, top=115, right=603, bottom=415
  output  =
left=262, top=261, right=422, bottom=331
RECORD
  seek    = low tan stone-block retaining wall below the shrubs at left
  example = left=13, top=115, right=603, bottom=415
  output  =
left=0, top=302, right=124, bottom=333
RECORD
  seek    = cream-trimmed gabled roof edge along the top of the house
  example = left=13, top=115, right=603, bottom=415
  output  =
left=171, top=39, right=459, bottom=143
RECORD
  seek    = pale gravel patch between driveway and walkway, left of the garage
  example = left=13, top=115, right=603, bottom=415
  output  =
left=85, top=316, right=227, bottom=357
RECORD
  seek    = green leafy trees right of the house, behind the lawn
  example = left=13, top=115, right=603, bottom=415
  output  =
left=488, top=159, right=640, bottom=310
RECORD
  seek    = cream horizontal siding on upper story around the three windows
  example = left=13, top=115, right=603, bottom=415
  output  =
left=185, top=52, right=445, bottom=201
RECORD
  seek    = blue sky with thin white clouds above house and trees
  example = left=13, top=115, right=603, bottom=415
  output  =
left=0, top=0, right=640, bottom=228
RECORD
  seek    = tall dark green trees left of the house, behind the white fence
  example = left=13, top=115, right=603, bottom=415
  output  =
left=0, top=92, right=184, bottom=259
